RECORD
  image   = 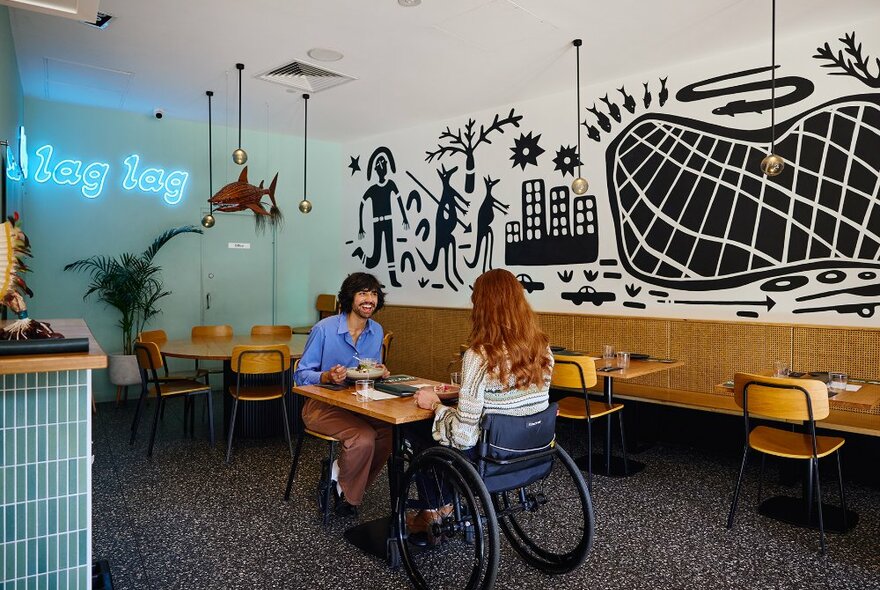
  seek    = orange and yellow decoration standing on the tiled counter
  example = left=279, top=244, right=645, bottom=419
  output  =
left=0, top=212, right=64, bottom=340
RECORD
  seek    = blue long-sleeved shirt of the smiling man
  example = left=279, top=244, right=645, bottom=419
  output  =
left=295, top=313, right=384, bottom=385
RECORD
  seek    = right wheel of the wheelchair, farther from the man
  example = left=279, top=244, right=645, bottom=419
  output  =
left=492, top=445, right=595, bottom=574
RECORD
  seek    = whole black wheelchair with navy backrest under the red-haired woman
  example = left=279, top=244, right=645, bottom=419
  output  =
left=393, top=403, right=594, bottom=590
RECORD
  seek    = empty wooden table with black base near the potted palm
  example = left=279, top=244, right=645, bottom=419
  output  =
left=157, top=334, right=308, bottom=438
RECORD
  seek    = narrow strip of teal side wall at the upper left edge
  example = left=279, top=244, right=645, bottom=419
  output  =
left=0, top=6, right=23, bottom=212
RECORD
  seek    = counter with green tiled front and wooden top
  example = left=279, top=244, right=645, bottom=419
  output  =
left=0, top=320, right=107, bottom=590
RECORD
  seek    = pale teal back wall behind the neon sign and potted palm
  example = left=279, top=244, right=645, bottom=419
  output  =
left=22, top=98, right=345, bottom=401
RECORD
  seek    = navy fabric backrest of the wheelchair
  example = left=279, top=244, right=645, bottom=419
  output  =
left=477, top=403, right=557, bottom=492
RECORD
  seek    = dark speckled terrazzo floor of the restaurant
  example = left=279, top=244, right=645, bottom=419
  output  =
left=93, top=398, right=880, bottom=590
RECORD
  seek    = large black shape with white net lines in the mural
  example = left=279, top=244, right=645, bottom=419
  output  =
left=606, top=94, right=880, bottom=292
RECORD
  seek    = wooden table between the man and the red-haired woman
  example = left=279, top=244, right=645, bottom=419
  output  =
left=293, top=377, right=448, bottom=567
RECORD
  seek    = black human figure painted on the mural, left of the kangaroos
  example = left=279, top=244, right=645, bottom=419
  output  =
left=352, top=146, right=409, bottom=287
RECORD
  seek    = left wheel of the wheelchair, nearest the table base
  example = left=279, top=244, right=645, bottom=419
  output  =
left=395, top=447, right=499, bottom=590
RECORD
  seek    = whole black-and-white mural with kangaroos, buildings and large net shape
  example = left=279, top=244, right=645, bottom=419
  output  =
left=347, top=27, right=880, bottom=318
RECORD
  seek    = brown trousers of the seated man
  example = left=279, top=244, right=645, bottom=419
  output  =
left=302, top=399, right=392, bottom=506
